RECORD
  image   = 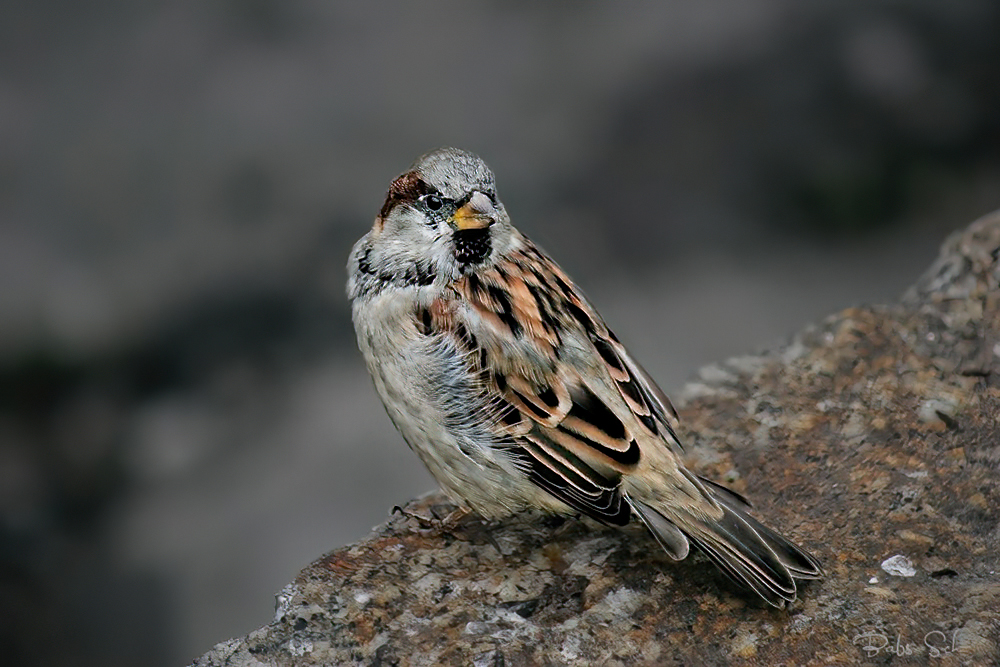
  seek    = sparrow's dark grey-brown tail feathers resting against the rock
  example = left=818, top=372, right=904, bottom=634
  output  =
left=628, top=479, right=823, bottom=607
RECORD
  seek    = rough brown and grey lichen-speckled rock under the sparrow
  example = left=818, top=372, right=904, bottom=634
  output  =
left=194, top=213, right=1000, bottom=667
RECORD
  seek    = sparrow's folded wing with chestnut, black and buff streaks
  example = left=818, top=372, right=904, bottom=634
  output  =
left=438, top=243, right=679, bottom=525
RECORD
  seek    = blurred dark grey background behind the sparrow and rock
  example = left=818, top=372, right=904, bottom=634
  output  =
left=0, top=0, right=1000, bottom=667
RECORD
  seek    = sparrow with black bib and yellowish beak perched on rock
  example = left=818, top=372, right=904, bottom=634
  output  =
left=347, top=148, right=822, bottom=607
